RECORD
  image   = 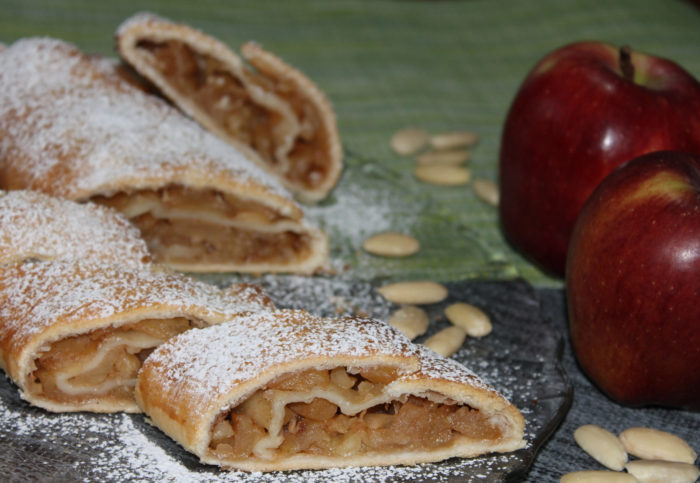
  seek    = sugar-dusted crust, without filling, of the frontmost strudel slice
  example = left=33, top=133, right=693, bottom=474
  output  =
left=136, top=311, right=524, bottom=471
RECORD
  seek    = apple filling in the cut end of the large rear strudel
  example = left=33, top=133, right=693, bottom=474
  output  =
left=93, top=186, right=312, bottom=271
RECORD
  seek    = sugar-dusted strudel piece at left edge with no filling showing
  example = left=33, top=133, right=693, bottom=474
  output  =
left=0, top=190, right=151, bottom=264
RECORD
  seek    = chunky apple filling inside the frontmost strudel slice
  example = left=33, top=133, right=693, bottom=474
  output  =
left=209, top=367, right=503, bottom=461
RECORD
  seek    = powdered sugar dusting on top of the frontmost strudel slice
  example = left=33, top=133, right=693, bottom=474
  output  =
left=144, top=311, right=417, bottom=408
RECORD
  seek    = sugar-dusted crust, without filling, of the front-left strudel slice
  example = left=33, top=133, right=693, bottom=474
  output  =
left=0, top=261, right=272, bottom=412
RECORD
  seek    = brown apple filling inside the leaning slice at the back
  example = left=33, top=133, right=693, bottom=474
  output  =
left=137, top=40, right=331, bottom=188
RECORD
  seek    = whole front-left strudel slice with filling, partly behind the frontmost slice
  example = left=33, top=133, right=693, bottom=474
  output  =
left=0, top=261, right=272, bottom=412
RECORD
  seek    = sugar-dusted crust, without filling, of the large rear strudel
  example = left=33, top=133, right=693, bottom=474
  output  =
left=0, top=38, right=328, bottom=273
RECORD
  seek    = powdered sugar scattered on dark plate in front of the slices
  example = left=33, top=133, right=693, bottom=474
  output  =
left=0, top=381, right=512, bottom=483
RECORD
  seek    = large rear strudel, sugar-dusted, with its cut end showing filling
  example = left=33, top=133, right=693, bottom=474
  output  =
left=0, top=38, right=328, bottom=273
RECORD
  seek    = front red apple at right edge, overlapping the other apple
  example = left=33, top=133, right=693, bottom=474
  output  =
left=566, top=151, right=700, bottom=409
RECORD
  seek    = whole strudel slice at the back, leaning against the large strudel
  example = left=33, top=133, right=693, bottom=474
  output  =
left=117, top=13, right=342, bottom=201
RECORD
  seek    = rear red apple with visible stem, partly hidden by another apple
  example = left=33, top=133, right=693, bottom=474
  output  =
left=500, top=42, right=700, bottom=276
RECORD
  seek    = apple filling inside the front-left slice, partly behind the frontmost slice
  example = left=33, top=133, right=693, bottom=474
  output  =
left=30, top=317, right=195, bottom=404
